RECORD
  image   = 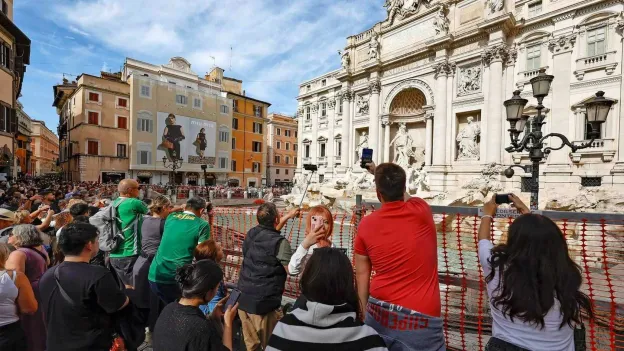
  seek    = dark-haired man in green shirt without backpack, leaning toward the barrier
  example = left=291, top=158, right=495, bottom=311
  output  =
left=148, top=197, right=210, bottom=304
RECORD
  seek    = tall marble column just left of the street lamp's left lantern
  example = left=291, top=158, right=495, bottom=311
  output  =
left=483, top=45, right=507, bottom=164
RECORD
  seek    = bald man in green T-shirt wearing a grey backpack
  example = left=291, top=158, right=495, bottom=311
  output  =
left=110, top=179, right=148, bottom=289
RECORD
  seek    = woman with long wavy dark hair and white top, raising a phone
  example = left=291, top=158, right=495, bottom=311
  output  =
left=479, top=194, right=593, bottom=351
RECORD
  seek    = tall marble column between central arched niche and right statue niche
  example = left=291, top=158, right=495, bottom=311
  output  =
left=433, top=61, right=450, bottom=166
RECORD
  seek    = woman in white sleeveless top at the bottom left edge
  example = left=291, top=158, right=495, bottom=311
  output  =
left=0, top=243, right=38, bottom=351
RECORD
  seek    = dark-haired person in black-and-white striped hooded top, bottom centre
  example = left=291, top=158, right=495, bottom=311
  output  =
left=266, top=247, right=387, bottom=351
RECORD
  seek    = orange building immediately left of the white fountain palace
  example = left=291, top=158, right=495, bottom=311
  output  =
left=267, top=113, right=298, bottom=186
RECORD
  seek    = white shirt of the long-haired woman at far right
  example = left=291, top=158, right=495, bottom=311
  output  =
left=479, top=239, right=574, bottom=351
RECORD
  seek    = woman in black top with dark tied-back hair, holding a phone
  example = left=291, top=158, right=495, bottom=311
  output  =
left=152, top=260, right=238, bottom=351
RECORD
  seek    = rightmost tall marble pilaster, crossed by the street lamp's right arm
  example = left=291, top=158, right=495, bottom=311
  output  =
left=548, top=34, right=576, bottom=168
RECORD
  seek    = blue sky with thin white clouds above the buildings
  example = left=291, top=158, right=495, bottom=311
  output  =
left=14, top=0, right=385, bottom=132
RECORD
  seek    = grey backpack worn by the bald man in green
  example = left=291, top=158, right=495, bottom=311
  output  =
left=89, top=199, right=139, bottom=252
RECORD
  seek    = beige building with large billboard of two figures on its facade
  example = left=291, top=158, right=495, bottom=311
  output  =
left=122, top=57, right=232, bottom=185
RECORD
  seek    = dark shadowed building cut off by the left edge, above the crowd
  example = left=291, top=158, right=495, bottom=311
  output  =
left=0, top=0, right=30, bottom=179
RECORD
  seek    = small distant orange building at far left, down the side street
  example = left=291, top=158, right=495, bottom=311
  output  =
left=30, top=119, right=59, bottom=176
